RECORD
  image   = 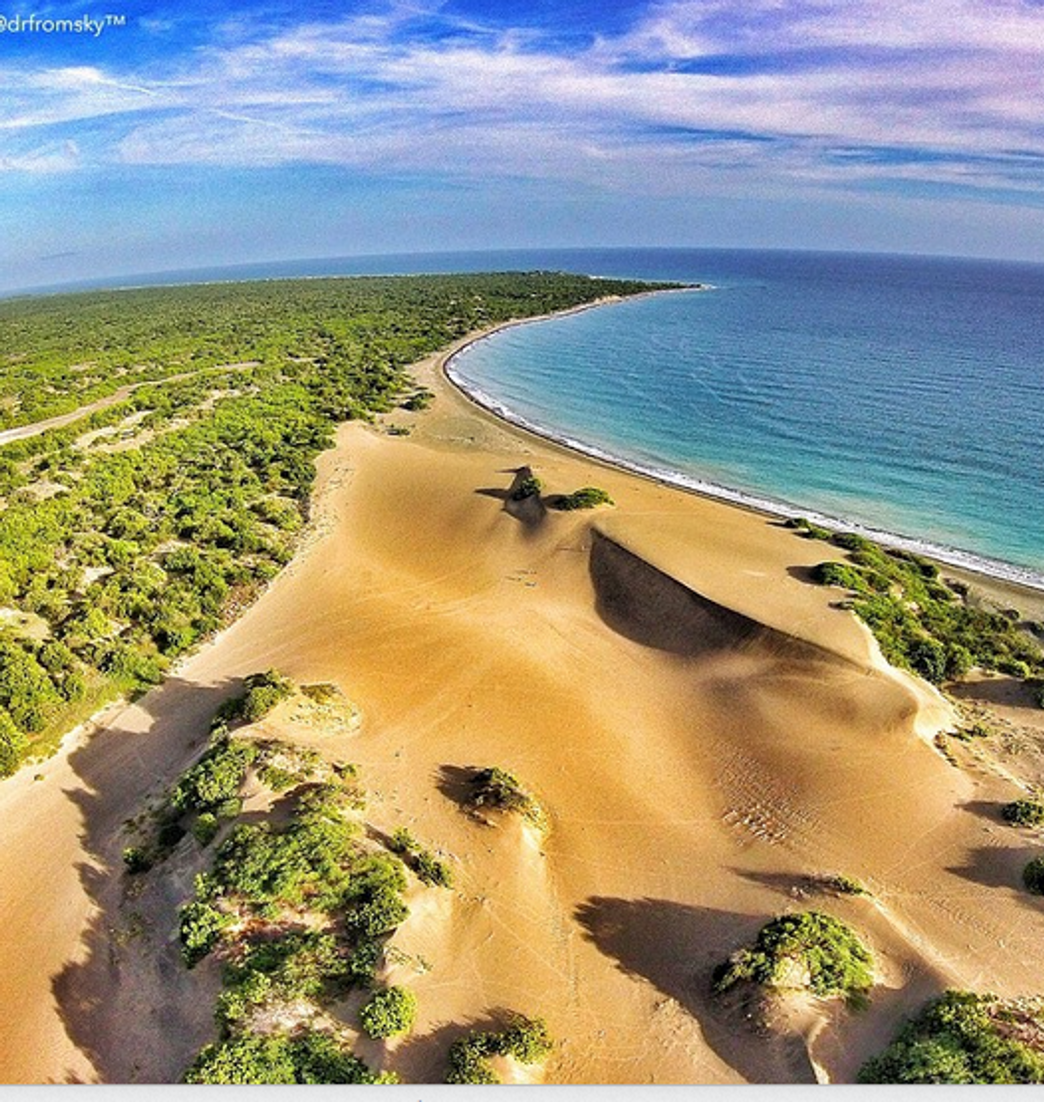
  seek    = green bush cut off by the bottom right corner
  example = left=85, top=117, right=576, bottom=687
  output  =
left=859, top=991, right=1044, bottom=1083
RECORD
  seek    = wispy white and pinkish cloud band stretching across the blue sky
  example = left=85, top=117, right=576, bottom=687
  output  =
left=0, top=0, right=1044, bottom=203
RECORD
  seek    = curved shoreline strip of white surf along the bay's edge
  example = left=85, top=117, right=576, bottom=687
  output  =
left=438, top=297, right=1044, bottom=599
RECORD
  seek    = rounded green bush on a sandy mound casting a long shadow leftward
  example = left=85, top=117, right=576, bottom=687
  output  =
left=714, top=911, right=873, bottom=1003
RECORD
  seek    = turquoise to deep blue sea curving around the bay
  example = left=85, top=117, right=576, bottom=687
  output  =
left=20, top=249, right=1044, bottom=586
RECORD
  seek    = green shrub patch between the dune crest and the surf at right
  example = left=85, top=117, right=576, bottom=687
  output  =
left=789, top=520, right=1044, bottom=684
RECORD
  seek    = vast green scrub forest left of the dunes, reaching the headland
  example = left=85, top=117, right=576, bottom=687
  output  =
left=0, top=272, right=661, bottom=776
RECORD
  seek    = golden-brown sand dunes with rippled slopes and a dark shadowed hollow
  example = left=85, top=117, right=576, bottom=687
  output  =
left=0, top=312, right=1044, bottom=1082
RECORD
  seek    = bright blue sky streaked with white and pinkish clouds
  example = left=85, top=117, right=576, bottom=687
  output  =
left=0, top=0, right=1044, bottom=289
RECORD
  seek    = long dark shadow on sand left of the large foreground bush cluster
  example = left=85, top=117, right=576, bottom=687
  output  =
left=52, top=678, right=240, bottom=1083
